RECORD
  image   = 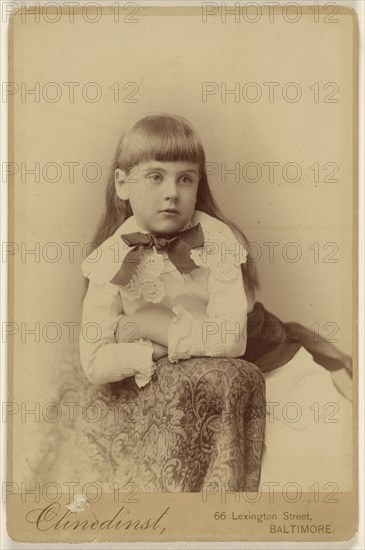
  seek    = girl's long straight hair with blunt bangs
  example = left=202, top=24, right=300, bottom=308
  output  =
left=93, top=114, right=259, bottom=296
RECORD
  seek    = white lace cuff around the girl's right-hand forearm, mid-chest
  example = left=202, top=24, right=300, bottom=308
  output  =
left=167, top=306, right=194, bottom=363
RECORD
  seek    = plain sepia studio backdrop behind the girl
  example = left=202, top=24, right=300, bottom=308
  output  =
left=10, top=6, right=354, bottom=484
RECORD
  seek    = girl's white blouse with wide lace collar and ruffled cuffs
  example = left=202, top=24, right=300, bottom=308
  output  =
left=80, top=210, right=247, bottom=387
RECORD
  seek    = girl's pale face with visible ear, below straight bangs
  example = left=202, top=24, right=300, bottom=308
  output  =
left=115, top=160, right=199, bottom=233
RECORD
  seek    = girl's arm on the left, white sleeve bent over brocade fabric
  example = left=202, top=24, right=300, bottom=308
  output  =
left=80, top=280, right=154, bottom=385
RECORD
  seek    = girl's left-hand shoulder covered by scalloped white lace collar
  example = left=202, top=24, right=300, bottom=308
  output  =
left=81, top=226, right=129, bottom=284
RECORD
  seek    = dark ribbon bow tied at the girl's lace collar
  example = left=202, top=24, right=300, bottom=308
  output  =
left=110, top=223, right=204, bottom=286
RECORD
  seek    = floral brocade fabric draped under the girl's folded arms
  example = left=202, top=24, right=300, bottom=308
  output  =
left=28, top=352, right=265, bottom=492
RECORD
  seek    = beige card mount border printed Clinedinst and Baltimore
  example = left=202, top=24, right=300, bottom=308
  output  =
left=7, top=5, right=359, bottom=543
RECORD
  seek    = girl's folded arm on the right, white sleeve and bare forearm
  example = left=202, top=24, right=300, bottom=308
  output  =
left=118, top=258, right=247, bottom=361
